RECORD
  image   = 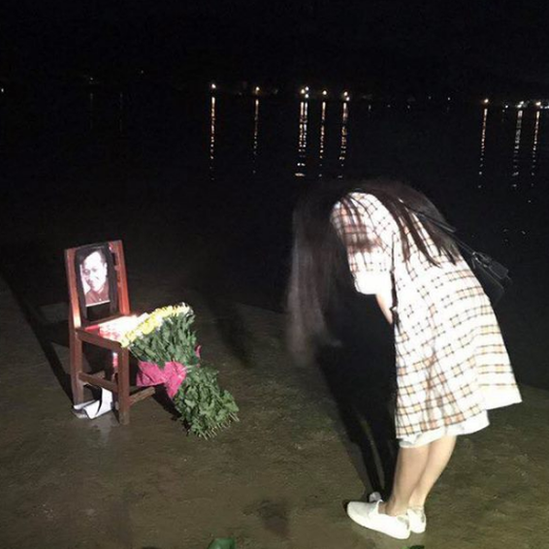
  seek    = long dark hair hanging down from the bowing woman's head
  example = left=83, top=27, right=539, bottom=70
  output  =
left=287, top=178, right=459, bottom=362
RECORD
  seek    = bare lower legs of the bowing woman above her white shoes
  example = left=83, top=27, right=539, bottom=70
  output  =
left=380, top=437, right=456, bottom=516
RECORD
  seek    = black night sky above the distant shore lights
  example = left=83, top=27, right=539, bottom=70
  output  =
left=0, top=0, right=549, bottom=93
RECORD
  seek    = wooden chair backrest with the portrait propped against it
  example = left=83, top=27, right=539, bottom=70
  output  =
left=65, top=240, right=130, bottom=328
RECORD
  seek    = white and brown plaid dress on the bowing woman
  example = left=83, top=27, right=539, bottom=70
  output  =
left=332, top=193, right=521, bottom=440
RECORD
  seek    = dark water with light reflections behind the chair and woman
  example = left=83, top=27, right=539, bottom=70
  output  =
left=0, top=88, right=549, bottom=384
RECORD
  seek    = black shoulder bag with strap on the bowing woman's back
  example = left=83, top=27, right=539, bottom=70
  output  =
left=408, top=207, right=512, bottom=306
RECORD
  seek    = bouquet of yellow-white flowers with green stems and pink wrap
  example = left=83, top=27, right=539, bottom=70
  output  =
left=120, top=303, right=238, bottom=438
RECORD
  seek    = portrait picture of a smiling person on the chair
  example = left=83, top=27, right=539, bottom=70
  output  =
left=75, top=242, right=118, bottom=320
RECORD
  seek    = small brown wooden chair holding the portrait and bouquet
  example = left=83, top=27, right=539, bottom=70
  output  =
left=65, top=240, right=154, bottom=425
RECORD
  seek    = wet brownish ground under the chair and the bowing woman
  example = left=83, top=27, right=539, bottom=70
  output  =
left=0, top=266, right=549, bottom=549
